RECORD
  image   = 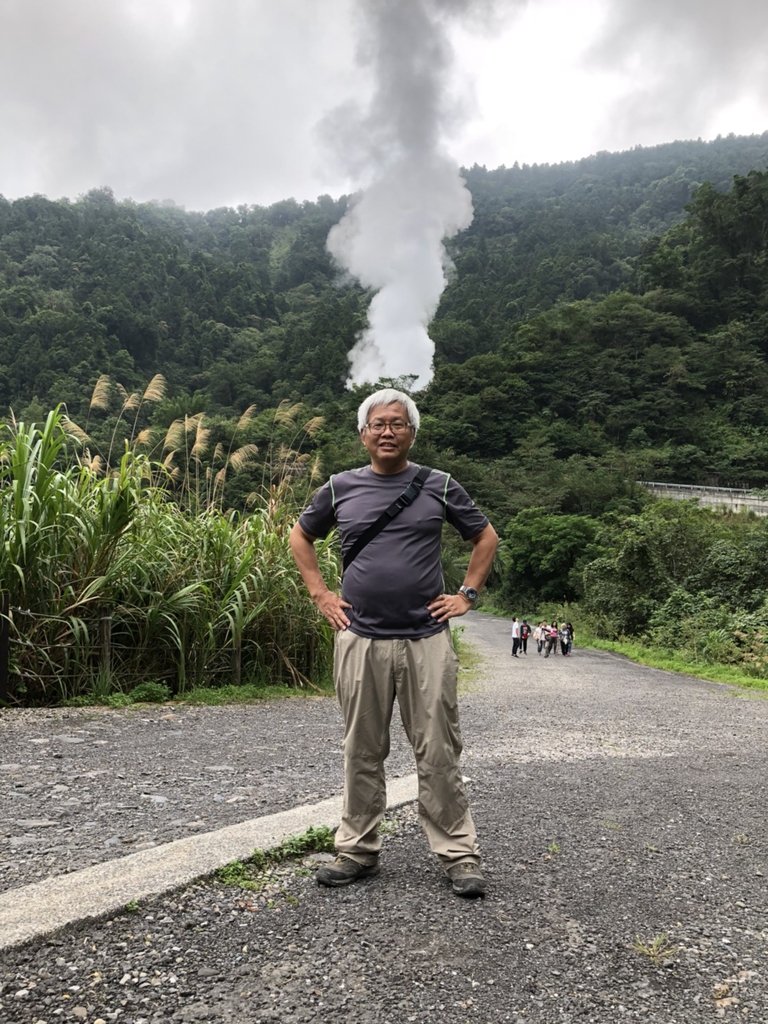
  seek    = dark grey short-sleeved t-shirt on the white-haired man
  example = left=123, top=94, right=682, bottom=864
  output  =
left=299, top=463, right=488, bottom=639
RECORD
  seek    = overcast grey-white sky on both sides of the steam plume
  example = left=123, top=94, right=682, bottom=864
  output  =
left=0, top=0, right=768, bottom=209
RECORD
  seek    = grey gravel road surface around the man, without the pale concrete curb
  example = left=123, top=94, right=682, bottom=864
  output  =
left=0, top=613, right=768, bottom=1024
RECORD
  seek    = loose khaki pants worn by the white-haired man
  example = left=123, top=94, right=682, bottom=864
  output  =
left=334, top=630, right=480, bottom=865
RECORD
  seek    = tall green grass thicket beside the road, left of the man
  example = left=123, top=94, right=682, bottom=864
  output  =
left=0, top=399, right=338, bottom=703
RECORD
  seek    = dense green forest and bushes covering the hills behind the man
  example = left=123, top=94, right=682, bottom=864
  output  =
left=0, top=133, right=768, bottom=700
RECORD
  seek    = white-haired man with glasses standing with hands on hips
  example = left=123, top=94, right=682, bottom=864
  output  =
left=291, top=388, right=499, bottom=897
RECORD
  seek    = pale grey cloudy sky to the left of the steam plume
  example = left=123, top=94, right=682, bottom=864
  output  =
left=0, top=0, right=355, bottom=208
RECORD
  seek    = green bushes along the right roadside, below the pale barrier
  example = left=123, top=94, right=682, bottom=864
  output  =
left=493, top=498, right=768, bottom=688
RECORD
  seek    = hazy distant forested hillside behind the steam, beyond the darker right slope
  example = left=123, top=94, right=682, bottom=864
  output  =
left=0, top=133, right=768, bottom=421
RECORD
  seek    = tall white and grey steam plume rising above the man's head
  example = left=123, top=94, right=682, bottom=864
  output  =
left=326, top=0, right=477, bottom=387
